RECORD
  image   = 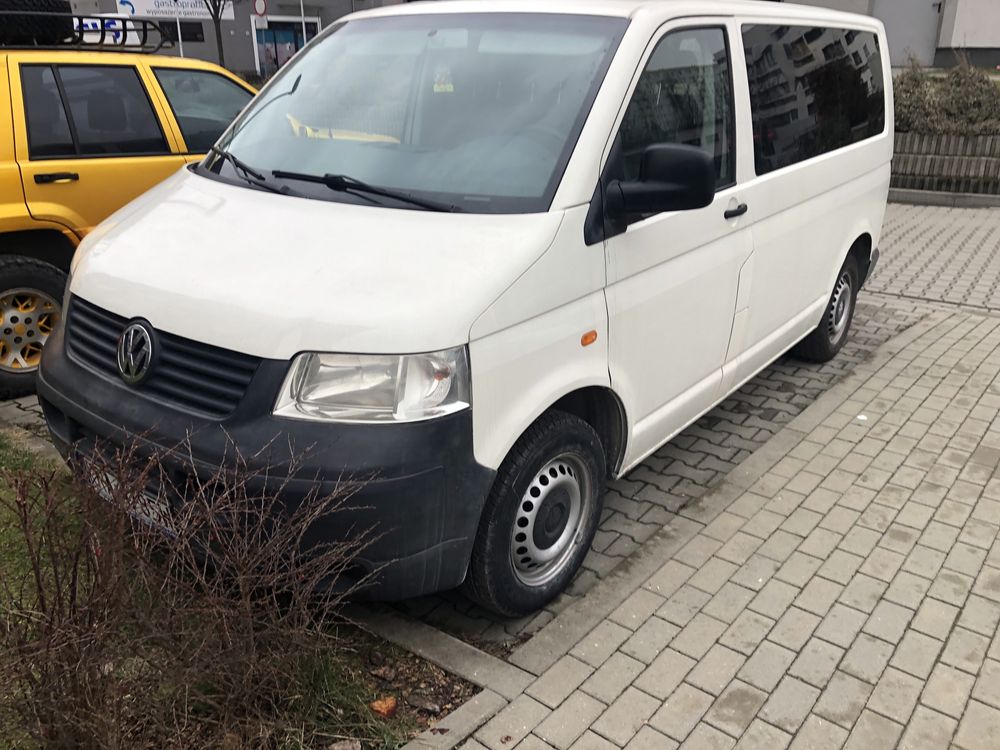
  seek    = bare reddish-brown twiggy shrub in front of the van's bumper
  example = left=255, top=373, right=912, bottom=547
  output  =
left=0, top=438, right=382, bottom=750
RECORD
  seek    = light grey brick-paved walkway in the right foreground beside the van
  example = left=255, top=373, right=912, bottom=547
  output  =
left=463, top=311, right=1000, bottom=750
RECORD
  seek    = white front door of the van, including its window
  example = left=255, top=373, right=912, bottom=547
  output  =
left=606, top=18, right=752, bottom=470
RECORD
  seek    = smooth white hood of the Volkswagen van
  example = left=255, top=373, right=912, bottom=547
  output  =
left=72, top=169, right=562, bottom=359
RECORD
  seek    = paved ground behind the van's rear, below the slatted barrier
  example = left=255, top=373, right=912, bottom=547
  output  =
left=868, top=203, right=1000, bottom=310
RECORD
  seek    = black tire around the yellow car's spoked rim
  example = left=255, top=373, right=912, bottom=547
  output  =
left=0, top=255, right=66, bottom=400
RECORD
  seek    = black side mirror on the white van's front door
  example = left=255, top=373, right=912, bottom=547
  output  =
left=607, top=143, right=715, bottom=216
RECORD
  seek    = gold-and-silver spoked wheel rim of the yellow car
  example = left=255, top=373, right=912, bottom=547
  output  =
left=0, top=287, right=62, bottom=374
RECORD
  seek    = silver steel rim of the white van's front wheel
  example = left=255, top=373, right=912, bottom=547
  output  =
left=510, top=453, right=593, bottom=586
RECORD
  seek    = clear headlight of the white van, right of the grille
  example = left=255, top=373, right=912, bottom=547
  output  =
left=274, top=346, right=471, bottom=422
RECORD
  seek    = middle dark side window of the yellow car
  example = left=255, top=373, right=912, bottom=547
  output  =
left=58, top=65, right=170, bottom=156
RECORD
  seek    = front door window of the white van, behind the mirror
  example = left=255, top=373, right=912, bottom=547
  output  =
left=620, top=27, right=736, bottom=188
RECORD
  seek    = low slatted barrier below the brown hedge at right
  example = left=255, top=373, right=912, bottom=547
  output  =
left=892, top=133, right=1000, bottom=195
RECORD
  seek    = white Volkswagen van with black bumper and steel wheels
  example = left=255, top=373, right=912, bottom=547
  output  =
left=38, top=0, right=893, bottom=614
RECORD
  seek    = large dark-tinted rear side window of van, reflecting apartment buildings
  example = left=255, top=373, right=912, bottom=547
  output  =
left=742, top=24, right=885, bottom=174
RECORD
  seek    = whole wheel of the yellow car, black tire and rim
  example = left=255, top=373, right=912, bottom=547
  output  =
left=0, top=256, right=66, bottom=399
